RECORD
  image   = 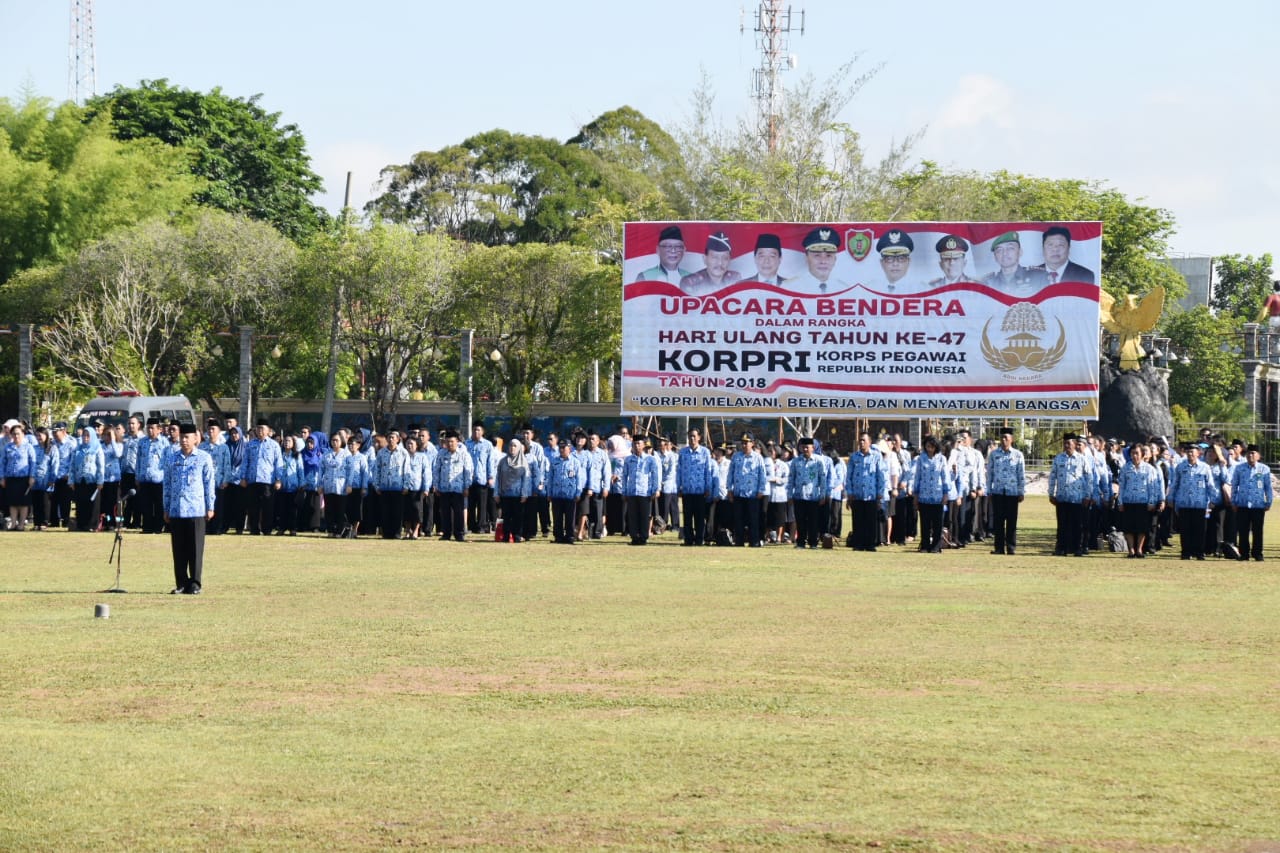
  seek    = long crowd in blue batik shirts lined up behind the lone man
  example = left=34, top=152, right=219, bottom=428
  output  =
left=0, top=418, right=1272, bottom=560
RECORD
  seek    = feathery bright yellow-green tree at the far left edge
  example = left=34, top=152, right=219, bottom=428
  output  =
left=0, top=99, right=204, bottom=283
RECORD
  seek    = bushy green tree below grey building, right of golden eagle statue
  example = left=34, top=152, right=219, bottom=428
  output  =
left=1162, top=305, right=1244, bottom=416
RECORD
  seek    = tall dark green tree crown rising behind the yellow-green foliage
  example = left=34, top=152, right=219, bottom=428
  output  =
left=86, top=79, right=325, bottom=240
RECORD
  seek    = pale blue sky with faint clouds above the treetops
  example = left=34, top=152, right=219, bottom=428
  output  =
left=0, top=0, right=1280, bottom=267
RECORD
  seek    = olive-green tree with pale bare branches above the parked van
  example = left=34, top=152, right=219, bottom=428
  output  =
left=0, top=210, right=302, bottom=403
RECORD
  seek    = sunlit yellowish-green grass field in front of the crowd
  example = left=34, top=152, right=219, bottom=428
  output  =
left=0, top=498, right=1280, bottom=853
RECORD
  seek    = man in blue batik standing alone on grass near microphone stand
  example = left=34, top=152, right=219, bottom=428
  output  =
left=163, top=424, right=218, bottom=596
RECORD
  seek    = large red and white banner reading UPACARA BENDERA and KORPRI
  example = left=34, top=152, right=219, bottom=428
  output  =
left=621, top=222, right=1102, bottom=419
